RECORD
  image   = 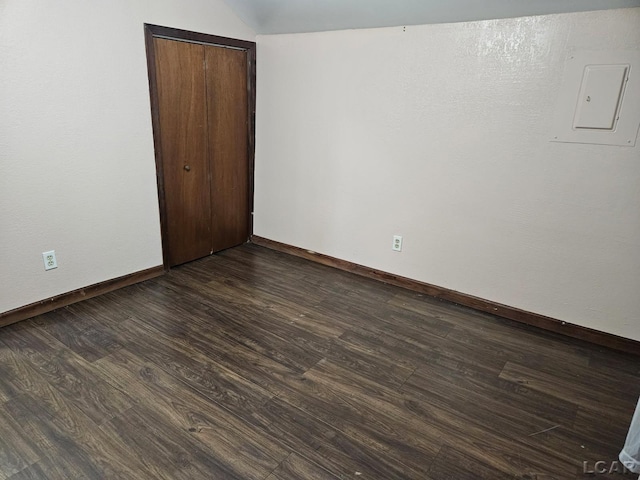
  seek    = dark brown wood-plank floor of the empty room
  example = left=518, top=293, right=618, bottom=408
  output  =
left=0, top=245, right=640, bottom=480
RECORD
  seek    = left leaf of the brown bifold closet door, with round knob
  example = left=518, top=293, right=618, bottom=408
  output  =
left=153, top=38, right=212, bottom=266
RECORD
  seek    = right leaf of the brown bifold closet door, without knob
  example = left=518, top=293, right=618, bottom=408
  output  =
left=205, top=46, right=250, bottom=252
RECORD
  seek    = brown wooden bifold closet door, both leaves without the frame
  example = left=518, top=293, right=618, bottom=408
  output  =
left=154, top=38, right=250, bottom=266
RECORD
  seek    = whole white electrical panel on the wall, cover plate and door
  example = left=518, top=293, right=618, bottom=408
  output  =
left=552, top=50, right=640, bottom=147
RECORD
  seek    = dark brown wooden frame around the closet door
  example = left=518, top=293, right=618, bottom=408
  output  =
left=144, top=23, right=256, bottom=271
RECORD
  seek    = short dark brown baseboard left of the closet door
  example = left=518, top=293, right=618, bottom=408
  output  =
left=0, top=265, right=164, bottom=327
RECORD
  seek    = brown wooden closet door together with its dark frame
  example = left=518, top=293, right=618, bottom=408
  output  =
left=145, top=24, right=256, bottom=270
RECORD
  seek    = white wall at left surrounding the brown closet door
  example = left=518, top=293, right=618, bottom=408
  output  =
left=0, top=0, right=255, bottom=312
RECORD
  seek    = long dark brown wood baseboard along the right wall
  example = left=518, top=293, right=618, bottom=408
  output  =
left=251, top=235, right=640, bottom=355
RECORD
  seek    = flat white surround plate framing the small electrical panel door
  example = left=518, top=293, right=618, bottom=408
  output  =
left=551, top=50, right=640, bottom=147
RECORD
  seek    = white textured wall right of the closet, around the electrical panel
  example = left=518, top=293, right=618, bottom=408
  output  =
left=255, top=9, right=640, bottom=340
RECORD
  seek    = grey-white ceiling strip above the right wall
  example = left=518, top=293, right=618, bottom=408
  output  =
left=224, top=0, right=640, bottom=34
